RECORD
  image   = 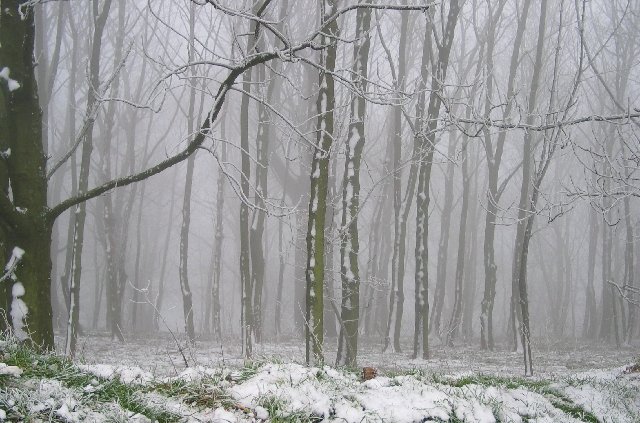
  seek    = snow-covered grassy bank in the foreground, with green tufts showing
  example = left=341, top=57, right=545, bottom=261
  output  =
left=0, top=343, right=640, bottom=423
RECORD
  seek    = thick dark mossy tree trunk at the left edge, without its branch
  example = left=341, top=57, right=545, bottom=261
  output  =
left=0, top=0, right=54, bottom=349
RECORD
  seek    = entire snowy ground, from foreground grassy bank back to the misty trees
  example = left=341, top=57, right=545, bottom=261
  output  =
left=0, top=334, right=640, bottom=423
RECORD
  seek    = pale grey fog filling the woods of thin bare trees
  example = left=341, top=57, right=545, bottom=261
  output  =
left=6, top=0, right=640, bottom=374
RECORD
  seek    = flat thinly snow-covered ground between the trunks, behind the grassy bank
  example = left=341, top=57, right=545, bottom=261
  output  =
left=74, top=334, right=640, bottom=378
